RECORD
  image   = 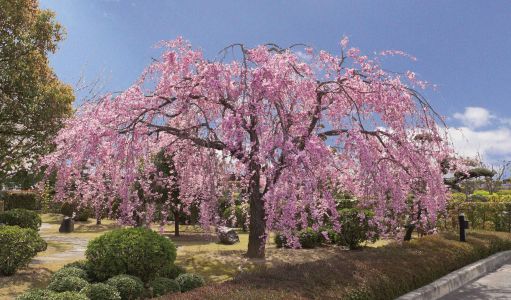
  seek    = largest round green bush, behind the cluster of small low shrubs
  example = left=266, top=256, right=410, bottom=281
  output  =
left=85, top=227, right=176, bottom=282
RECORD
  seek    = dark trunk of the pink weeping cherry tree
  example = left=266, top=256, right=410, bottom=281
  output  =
left=247, top=162, right=266, bottom=258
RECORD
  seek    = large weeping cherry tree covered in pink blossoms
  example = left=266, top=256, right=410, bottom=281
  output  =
left=45, top=38, right=452, bottom=257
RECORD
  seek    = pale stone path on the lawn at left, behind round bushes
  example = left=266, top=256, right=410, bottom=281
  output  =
left=32, top=223, right=89, bottom=264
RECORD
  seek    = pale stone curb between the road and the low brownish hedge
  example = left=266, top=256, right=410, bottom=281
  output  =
left=396, top=250, right=511, bottom=300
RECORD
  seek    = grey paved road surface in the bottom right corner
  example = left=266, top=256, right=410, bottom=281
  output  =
left=440, top=261, right=511, bottom=300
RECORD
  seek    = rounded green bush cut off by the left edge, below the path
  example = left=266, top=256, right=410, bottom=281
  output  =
left=0, top=226, right=47, bottom=276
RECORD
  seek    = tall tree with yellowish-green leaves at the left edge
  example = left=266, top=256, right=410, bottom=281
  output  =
left=0, top=0, right=74, bottom=185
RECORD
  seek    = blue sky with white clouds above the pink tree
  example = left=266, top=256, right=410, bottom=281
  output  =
left=40, top=0, right=511, bottom=162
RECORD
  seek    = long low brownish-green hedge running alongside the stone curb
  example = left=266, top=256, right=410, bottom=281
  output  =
left=175, top=230, right=511, bottom=300
